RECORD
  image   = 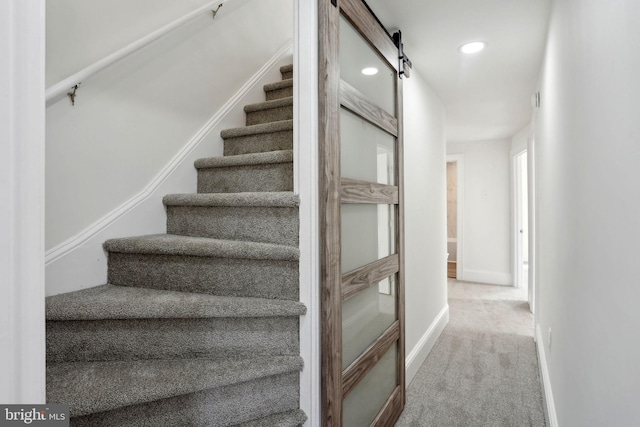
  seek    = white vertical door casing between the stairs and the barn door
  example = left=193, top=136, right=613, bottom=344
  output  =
left=293, top=0, right=322, bottom=426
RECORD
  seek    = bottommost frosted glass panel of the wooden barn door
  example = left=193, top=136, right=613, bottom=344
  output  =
left=342, top=345, right=398, bottom=427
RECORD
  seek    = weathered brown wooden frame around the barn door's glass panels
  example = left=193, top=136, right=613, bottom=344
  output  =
left=318, top=0, right=406, bottom=427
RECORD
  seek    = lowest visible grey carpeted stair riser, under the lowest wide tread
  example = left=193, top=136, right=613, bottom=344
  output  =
left=71, top=372, right=300, bottom=427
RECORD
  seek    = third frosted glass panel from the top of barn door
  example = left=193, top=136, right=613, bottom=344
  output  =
left=341, top=203, right=396, bottom=273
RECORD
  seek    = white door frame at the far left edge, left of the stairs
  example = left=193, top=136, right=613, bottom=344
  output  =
left=0, top=0, right=46, bottom=404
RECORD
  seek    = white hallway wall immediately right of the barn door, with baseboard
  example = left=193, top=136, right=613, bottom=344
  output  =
left=404, top=70, right=449, bottom=384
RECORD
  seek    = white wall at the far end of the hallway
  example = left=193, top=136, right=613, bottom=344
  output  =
left=447, top=139, right=513, bottom=285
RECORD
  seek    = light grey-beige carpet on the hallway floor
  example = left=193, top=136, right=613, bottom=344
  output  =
left=396, top=279, right=545, bottom=427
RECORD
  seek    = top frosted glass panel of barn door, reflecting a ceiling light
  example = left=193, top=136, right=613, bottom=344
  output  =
left=340, top=16, right=396, bottom=117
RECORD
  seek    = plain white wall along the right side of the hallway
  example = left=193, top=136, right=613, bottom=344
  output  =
left=535, top=0, right=640, bottom=426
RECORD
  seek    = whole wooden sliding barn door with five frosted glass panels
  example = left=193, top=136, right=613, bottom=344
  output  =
left=319, top=0, right=405, bottom=427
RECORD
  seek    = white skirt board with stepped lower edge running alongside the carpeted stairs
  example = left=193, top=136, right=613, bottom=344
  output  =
left=45, top=41, right=293, bottom=296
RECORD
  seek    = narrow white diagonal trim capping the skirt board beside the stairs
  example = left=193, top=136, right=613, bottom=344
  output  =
left=45, top=40, right=293, bottom=265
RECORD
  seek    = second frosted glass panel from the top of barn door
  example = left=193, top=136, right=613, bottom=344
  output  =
left=340, top=108, right=396, bottom=185
